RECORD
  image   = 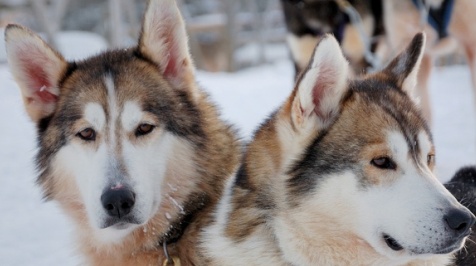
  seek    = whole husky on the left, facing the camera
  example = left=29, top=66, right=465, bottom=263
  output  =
left=5, top=0, right=240, bottom=265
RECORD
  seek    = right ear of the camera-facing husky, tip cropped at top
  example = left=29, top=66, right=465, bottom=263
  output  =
left=139, top=0, right=195, bottom=87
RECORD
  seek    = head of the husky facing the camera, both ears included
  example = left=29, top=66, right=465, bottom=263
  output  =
left=5, top=0, right=203, bottom=241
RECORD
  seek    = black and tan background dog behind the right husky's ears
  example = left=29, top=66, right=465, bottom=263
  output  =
left=281, top=0, right=385, bottom=77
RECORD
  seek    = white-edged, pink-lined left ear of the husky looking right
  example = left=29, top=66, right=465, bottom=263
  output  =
left=291, top=35, right=349, bottom=129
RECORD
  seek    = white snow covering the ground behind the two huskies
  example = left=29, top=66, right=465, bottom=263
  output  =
left=0, top=32, right=476, bottom=266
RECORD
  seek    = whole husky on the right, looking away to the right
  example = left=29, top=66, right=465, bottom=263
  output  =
left=201, top=34, right=475, bottom=265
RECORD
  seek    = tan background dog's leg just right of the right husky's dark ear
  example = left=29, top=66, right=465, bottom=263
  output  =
left=415, top=54, right=433, bottom=126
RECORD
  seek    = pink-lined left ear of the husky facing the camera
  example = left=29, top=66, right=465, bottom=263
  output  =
left=5, top=24, right=68, bottom=122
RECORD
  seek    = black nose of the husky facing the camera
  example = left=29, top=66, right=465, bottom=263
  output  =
left=101, top=189, right=135, bottom=218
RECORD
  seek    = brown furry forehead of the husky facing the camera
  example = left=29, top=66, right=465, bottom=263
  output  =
left=60, top=50, right=167, bottom=117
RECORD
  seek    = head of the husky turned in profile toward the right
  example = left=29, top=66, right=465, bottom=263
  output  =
left=270, top=34, right=474, bottom=261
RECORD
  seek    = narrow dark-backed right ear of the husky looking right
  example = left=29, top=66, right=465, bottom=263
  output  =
left=384, top=33, right=426, bottom=96
